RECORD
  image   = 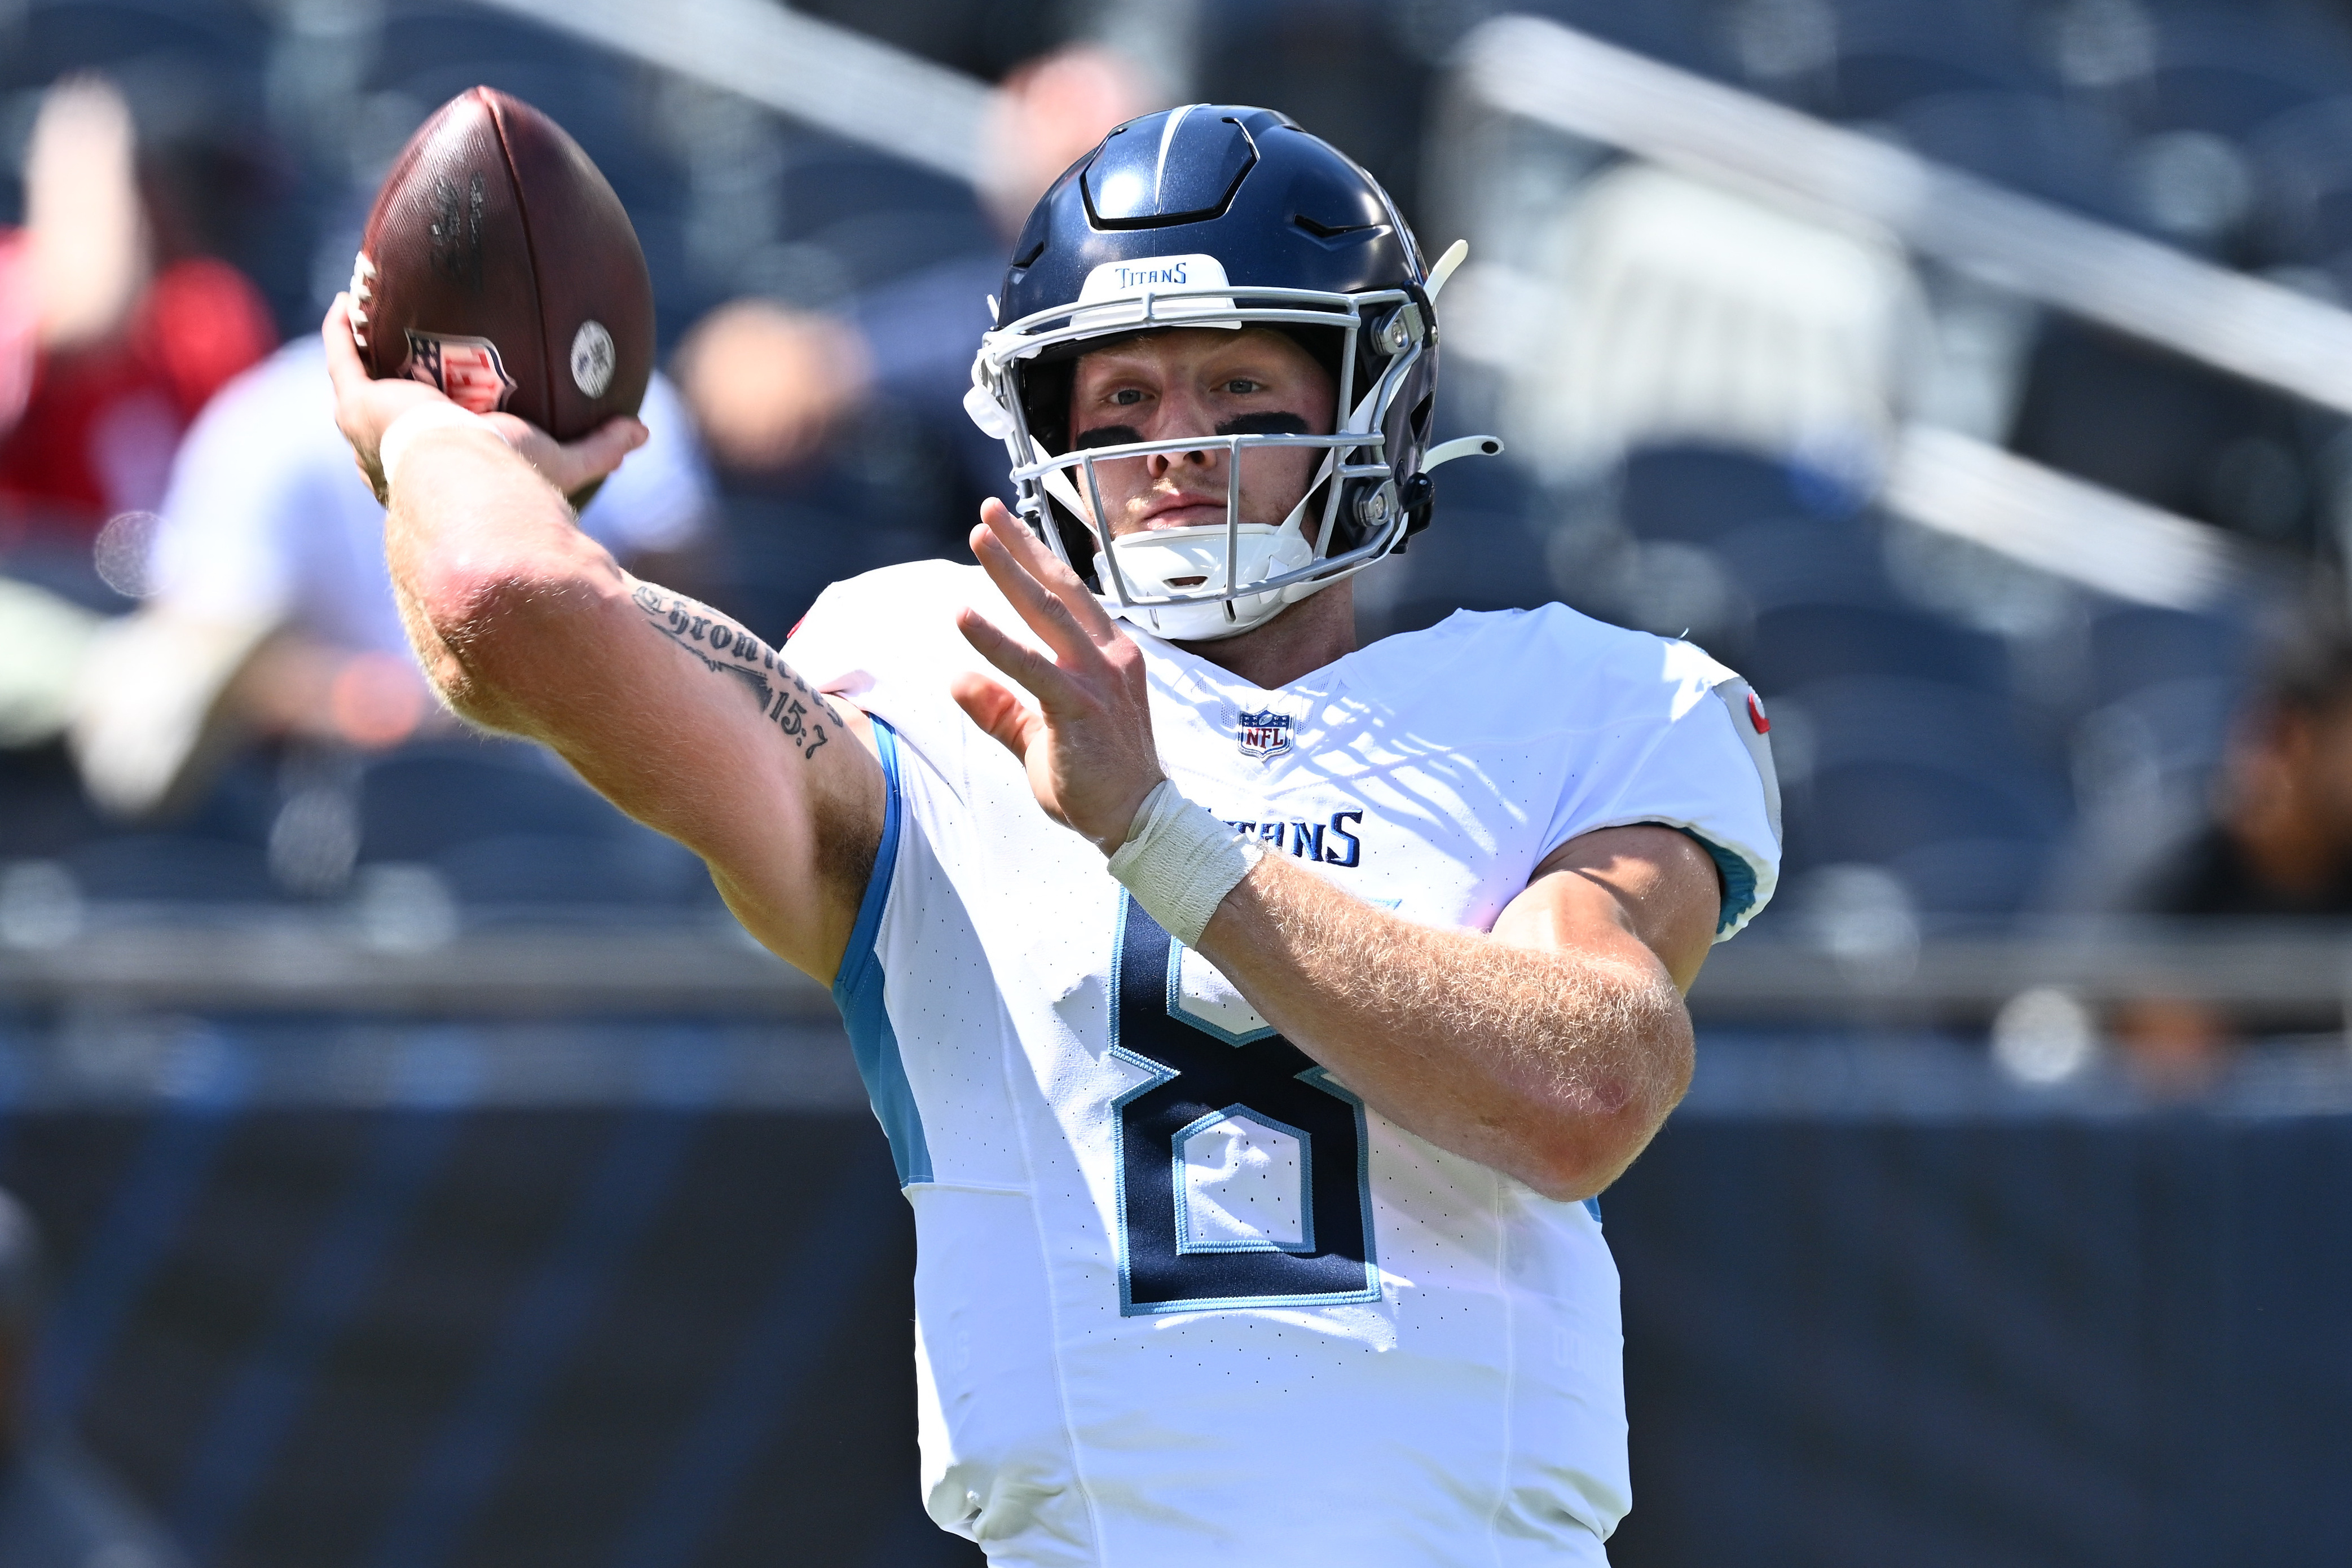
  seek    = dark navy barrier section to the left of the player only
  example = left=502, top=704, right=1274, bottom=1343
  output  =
left=0, top=1020, right=979, bottom=1568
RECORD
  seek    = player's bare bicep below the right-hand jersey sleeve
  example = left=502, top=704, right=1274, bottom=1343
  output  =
left=1494, top=825, right=1724, bottom=990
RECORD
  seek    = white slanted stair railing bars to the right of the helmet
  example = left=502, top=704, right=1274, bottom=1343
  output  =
left=1451, top=16, right=2352, bottom=609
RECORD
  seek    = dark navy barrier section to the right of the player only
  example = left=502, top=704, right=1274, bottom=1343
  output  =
left=1604, top=1039, right=2352, bottom=1568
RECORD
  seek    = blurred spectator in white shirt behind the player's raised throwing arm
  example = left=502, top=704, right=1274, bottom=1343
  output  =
left=59, top=336, right=713, bottom=816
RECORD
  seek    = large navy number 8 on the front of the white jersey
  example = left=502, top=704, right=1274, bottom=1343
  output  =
left=1110, top=896, right=1381, bottom=1316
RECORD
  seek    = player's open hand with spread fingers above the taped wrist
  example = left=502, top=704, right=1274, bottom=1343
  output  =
left=950, top=501, right=1164, bottom=856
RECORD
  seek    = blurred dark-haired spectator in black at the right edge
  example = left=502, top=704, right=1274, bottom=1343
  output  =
left=2115, top=616, right=2352, bottom=1093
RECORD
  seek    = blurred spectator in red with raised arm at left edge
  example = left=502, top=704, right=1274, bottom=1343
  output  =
left=0, top=78, right=275, bottom=550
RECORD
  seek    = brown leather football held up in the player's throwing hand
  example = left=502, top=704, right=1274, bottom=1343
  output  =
left=350, top=87, right=654, bottom=442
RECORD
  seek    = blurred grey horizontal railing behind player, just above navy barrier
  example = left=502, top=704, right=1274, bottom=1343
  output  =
left=0, top=905, right=2352, bottom=1030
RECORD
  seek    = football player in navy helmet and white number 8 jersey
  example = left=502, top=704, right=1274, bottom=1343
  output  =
left=327, top=103, right=1778, bottom=1568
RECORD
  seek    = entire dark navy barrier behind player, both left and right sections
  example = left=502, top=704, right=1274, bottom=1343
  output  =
left=0, top=1018, right=2352, bottom=1568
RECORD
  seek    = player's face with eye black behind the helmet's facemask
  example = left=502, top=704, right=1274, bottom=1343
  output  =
left=1070, top=327, right=1338, bottom=538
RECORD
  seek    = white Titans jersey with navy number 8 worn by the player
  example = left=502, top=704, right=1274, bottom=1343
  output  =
left=786, top=562, right=1778, bottom=1568
